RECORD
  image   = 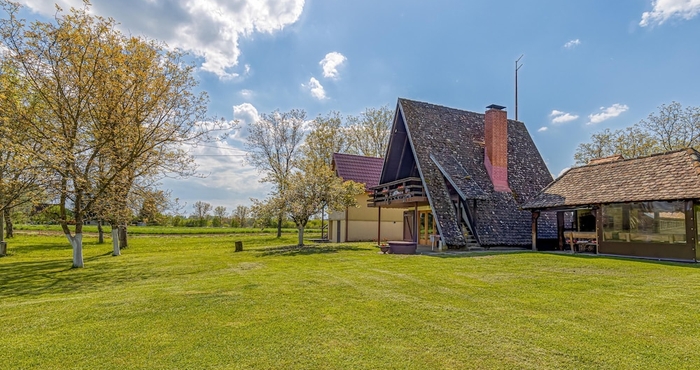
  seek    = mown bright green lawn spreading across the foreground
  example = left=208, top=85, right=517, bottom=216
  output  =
left=0, top=233, right=700, bottom=369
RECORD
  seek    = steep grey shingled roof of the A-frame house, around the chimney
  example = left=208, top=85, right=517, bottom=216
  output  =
left=399, top=99, right=552, bottom=246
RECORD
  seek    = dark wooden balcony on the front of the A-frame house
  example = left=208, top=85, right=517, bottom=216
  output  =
left=368, top=177, right=428, bottom=208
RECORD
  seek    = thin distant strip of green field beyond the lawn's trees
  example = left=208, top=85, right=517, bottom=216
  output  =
left=14, top=225, right=320, bottom=236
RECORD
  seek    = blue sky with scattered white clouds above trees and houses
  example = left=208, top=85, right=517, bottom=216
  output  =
left=12, top=0, right=700, bottom=212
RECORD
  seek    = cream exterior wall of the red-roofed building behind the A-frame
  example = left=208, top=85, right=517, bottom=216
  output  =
left=328, top=194, right=403, bottom=243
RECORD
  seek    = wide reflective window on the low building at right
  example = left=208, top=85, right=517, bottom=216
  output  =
left=603, top=201, right=686, bottom=243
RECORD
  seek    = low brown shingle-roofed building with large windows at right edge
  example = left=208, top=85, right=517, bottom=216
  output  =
left=523, top=149, right=700, bottom=262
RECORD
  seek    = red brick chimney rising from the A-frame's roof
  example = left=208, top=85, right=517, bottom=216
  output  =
left=484, top=104, right=510, bottom=192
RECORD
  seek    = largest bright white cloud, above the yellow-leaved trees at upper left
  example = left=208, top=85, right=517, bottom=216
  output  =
left=21, top=0, right=304, bottom=79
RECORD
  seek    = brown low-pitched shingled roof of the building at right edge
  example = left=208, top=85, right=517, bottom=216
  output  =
left=523, top=149, right=700, bottom=209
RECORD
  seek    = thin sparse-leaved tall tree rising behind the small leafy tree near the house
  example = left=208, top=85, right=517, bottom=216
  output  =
left=246, top=109, right=306, bottom=238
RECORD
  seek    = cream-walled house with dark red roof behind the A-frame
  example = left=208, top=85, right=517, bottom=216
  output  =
left=328, top=153, right=403, bottom=243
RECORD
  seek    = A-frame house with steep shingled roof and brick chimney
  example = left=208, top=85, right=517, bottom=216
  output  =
left=373, top=99, right=555, bottom=248
